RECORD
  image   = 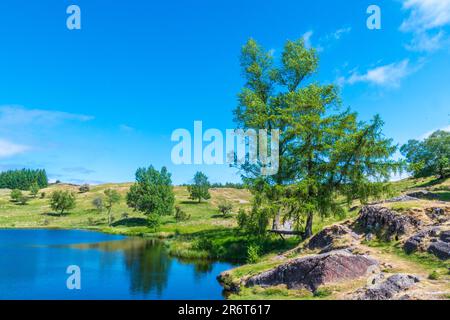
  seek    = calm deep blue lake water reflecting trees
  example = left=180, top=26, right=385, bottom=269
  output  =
left=0, top=230, right=232, bottom=299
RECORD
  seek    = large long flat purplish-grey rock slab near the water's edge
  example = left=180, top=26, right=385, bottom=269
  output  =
left=245, top=250, right=378, bottom=291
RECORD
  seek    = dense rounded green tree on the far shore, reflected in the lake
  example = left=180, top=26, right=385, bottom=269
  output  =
left=127, top=166, right=175, bottom=216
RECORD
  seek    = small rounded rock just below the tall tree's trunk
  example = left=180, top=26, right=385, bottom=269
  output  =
left=307, top=225, right=359, bottom=253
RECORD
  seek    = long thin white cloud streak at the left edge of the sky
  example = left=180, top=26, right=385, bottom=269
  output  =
left=0, top=106, right=93, bottom=126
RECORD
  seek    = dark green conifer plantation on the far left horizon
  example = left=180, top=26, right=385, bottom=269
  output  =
left=0, top=169, right=48, bottom=190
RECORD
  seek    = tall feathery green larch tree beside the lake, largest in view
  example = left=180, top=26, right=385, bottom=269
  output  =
left=234, top=39, right=398, bottom=237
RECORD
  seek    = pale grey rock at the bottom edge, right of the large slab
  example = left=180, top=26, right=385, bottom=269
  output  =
left=355, top=274, right=420, bottom=300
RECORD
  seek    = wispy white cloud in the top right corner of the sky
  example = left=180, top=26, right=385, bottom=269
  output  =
left=400, top=0, right=450, bottom=52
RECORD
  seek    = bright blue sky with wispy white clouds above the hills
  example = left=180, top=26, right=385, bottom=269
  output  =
left=0, top=0, right=450, bottom=183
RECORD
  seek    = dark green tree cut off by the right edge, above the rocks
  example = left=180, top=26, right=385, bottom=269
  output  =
left=400, top=130, right=450, bottom=179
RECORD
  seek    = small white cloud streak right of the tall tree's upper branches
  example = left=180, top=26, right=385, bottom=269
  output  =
left=338, top=59, right=418, bottom=87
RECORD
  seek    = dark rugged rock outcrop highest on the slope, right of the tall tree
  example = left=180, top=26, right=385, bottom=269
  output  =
left=356, top=206, right=421, bottom=239
